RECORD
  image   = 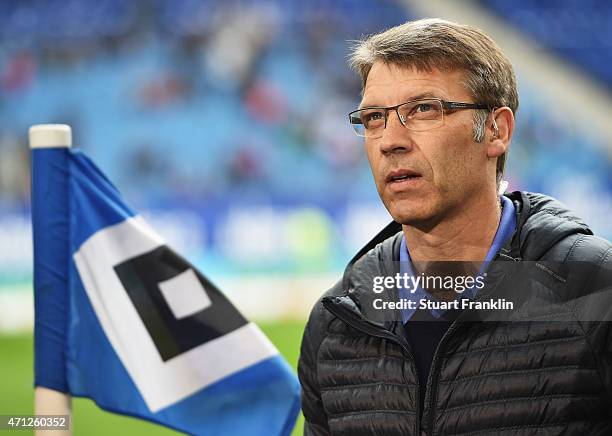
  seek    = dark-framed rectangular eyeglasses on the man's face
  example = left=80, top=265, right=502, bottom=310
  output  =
left=349, top=98, right=489, bottom=139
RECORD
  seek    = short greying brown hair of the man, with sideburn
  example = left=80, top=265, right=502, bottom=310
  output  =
left=349, top=18, right=519, bottom=186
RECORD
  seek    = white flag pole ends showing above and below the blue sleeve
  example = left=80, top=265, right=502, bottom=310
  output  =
left=28, top=124, right=72, bottom=436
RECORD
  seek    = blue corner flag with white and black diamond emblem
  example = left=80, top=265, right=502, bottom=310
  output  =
left=32, top=141, right=299, bottom=436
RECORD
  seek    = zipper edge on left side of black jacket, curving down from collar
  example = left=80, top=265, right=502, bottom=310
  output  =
left=323, top=299, right=421, bottom=435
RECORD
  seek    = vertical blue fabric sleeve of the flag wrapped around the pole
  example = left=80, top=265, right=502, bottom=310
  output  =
left=32, top=148, right=70, bottom=392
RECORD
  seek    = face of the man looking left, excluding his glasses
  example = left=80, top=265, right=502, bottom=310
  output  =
left=361, top=61, right=490, bottom=225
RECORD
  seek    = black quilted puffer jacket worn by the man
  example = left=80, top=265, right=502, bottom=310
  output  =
left=298, top=192, right=612, bottom=436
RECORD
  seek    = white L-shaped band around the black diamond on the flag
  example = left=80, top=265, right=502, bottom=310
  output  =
left=74, top=217, right=278, bottom=412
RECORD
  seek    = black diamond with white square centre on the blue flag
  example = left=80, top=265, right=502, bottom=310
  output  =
left=114, top=246, right=247, bottom=362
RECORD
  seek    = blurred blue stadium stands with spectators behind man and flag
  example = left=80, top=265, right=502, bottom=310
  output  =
left=0, top=0, right=612, bottom=276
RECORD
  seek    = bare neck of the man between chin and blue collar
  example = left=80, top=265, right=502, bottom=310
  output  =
left=402, top=190, right=501, bottom=262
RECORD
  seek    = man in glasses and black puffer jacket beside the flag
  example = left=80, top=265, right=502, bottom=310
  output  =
left=298, top=19, right=612, bottom=435
